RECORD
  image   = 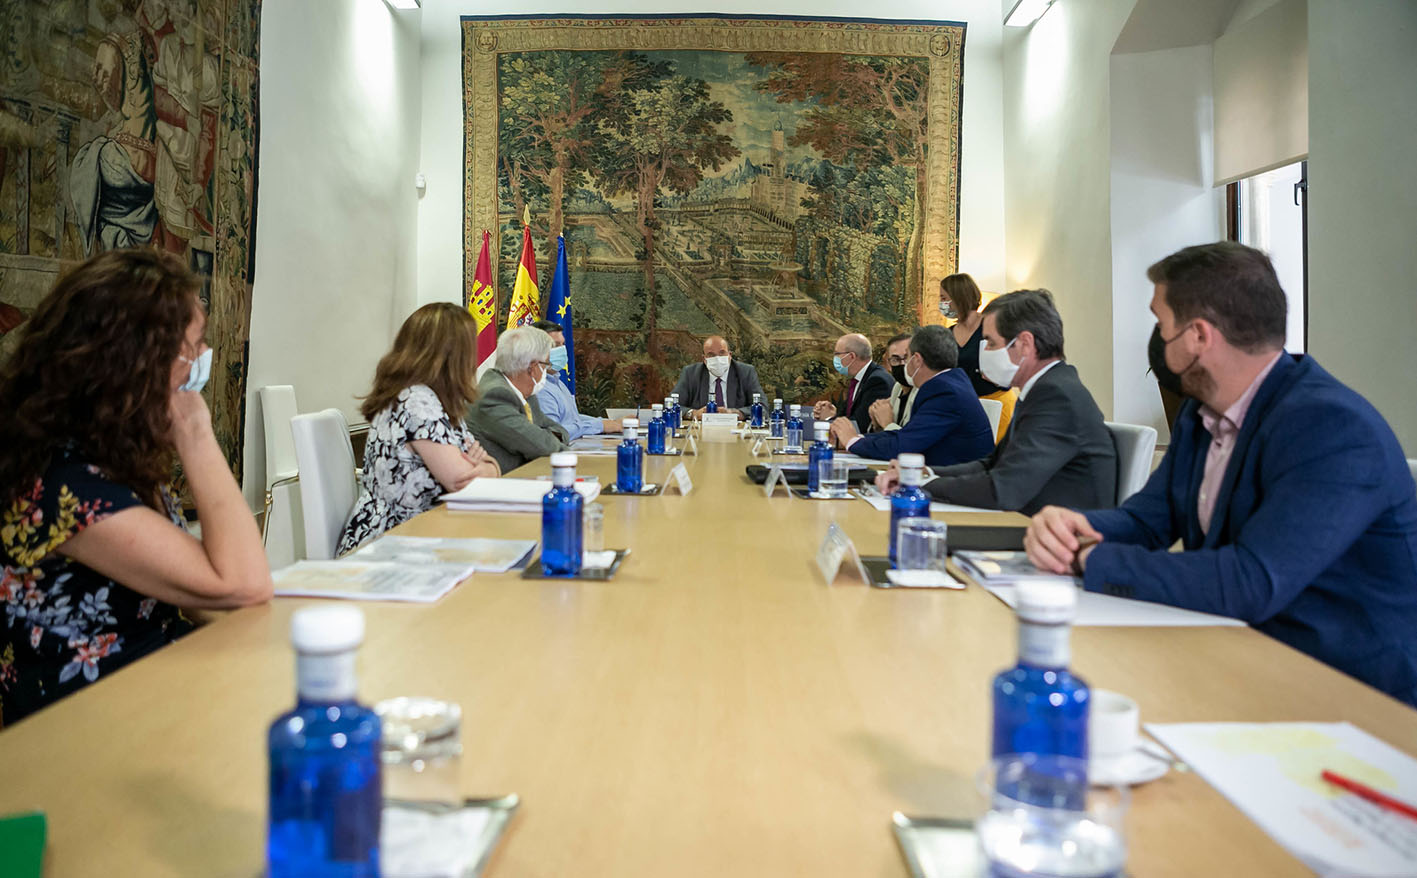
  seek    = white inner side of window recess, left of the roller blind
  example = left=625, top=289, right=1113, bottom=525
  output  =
left=1111, top=45, right=1224, bottom=442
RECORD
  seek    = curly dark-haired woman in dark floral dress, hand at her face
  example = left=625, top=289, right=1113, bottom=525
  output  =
left=0, top=249, right=271, bottom=726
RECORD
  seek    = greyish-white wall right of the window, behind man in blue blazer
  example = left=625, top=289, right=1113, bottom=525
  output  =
left=1309, top=0, right=1417, bottom=457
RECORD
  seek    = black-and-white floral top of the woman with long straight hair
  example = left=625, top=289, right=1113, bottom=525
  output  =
left=336, top=384, right=472, bottom=555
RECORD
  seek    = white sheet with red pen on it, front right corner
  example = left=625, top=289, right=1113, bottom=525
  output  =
left=1146, top=722, right=1417, bottom=878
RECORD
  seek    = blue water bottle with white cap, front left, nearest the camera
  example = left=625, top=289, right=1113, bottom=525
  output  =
left=266, top=606, right=384, bottom=878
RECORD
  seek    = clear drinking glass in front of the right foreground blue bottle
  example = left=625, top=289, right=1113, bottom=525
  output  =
left=975, top=753, right=1128, bottom=878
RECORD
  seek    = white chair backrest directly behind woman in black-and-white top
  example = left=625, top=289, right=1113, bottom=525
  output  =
left=290, top=408, right=359, bottom=561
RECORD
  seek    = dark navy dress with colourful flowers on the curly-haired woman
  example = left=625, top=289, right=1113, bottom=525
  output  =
left=0, top=446, right=194, bottom=728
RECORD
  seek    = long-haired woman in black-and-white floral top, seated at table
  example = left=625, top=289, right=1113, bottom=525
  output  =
left=336, top=302, right=502, bottom=555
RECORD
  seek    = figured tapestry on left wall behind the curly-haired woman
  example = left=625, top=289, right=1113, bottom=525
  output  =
left=0, top=0, right=261, bottom=477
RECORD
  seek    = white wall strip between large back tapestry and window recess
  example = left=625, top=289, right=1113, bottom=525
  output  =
left=1003, top=0, right=1135, bottom=416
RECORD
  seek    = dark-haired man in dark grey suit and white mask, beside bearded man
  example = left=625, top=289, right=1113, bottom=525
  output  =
left=876, top=290, right=1117, bottom=514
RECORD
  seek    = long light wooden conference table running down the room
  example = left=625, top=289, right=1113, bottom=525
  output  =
left=0, top=442, right=1417, bottom=878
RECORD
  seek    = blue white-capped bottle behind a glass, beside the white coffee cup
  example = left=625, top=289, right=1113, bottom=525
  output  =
left=993, top=581, right=1090, bottom=759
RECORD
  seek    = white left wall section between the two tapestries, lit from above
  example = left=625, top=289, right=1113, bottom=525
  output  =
left=244, top=0, right=419, bottom=507
